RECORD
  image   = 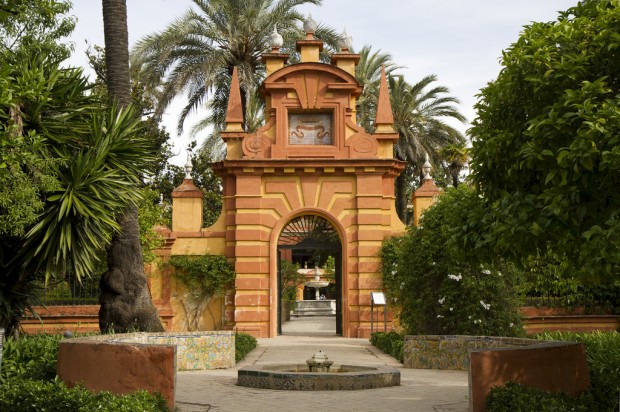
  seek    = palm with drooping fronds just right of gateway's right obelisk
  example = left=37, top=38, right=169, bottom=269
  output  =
left=389, top=75, right=465, bottom=221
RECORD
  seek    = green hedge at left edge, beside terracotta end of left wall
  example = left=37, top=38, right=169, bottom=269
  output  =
left=0, top=334, right=62, bottom=382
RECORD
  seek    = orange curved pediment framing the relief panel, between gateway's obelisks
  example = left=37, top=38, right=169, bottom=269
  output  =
left=242, top=62, right=378, bottom=159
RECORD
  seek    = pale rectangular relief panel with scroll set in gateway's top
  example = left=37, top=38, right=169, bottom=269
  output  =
left=288, top=113, right=334, bottom=146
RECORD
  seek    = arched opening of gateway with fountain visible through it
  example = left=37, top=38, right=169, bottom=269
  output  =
left=277, top=215, right=342, bottom=335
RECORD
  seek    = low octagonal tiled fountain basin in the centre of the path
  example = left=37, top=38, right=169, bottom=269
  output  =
left=237, top=364, right=400, bottom=391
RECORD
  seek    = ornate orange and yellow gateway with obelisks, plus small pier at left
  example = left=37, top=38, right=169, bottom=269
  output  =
left=162, top=22, right=404, bottom=337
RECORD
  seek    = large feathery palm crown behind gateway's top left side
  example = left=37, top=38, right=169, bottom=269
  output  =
left=132, top=0, right=337, bottom=135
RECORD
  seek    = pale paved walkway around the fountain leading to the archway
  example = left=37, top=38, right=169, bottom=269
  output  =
left=176, top=319, right=469, bottom=412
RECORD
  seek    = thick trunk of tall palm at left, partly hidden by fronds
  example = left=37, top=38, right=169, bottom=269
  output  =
left=99, top=0, right=163, bottom=332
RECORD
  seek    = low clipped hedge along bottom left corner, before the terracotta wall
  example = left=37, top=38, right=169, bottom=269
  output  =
left=0, top=378, right=170, bottom=412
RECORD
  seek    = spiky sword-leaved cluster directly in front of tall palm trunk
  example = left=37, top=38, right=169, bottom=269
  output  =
left=24, top=99, right=150, bottom=279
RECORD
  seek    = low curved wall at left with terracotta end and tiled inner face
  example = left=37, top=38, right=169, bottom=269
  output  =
left=57, top=331, right=235, bottom=408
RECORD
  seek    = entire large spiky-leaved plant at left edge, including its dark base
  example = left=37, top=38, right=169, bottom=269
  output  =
left=0, top=55, right=151, bottom=330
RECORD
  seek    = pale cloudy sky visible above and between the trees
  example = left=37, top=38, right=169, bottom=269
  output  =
left=66, top=0, right=577, bottom=165
